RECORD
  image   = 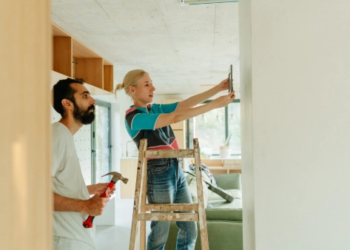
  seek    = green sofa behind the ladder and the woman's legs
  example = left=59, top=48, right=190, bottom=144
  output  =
left=165, top=174, right=243, bottom=250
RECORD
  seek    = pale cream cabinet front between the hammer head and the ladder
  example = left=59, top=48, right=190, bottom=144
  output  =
left=120, top=158, right=137, bottom=199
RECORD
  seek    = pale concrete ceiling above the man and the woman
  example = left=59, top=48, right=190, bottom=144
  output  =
left=51, top=0, right=239, bottom=94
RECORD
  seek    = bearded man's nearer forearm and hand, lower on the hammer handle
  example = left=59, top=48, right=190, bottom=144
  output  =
left=53, top=193, right=109, bottom=216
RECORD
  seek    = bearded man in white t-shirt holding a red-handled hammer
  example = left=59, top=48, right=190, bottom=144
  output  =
left=51, top=78, right=114, bottom=250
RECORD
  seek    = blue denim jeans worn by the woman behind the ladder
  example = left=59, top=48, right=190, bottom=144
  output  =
left=147, top=159, right=197, bottom=250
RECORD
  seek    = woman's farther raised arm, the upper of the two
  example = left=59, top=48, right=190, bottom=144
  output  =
left=176, top=79, right=228, bottom=110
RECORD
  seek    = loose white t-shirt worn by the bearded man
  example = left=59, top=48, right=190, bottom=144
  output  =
left=52, top=122, right=95, bottom=248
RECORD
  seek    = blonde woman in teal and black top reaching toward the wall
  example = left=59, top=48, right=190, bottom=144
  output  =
left=116, top=69, right=235, bottom=250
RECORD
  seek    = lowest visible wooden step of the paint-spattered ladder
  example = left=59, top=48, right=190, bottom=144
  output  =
left=137, top=213, right=199, bottom=221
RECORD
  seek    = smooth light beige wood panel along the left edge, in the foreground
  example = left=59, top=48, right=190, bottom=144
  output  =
left=0, top=0, right=52, bottom=250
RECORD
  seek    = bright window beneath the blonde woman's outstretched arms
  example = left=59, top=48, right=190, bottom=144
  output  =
left=186, top=100, right=241, bottom=156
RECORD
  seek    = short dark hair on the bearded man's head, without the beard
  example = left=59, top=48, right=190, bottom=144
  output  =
left=52, top=78, right=84, bottom=117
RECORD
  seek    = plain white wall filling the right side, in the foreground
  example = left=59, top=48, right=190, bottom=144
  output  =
left=240, top=0, right=350, bottom=250
